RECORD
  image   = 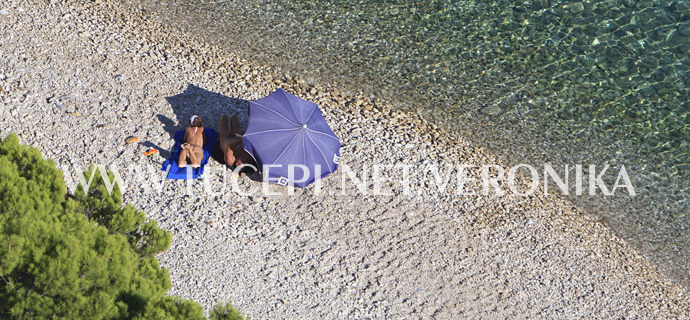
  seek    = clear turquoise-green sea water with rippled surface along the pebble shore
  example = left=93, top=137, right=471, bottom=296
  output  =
left=144, top=0, right=690, bottom=285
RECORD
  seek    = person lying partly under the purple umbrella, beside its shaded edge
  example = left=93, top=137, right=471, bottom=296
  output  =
left=218, top=114, right=256, bottom=171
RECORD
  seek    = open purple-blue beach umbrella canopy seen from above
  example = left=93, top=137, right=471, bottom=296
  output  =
left=242, top=89, right=340, bottom=188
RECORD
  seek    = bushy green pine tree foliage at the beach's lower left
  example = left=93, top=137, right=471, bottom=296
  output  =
left=0, top=135, right=242, bottom=319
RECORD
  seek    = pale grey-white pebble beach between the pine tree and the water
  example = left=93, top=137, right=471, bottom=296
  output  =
left=0, top=0, right=690, bottom=319
